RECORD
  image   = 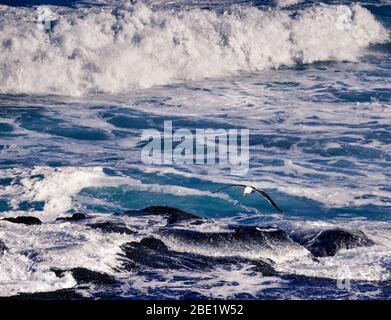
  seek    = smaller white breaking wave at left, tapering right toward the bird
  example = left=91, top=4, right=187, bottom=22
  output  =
left=0, top=167, right=230, bottom=221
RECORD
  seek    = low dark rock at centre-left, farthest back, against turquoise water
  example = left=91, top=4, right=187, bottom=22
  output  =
left=115, top=206, right=203, bottom=224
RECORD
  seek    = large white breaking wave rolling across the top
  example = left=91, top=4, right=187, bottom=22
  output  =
left=0, top=4, right=388, bottom=96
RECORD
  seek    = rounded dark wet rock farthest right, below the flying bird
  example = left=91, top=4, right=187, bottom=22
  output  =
left=292, top=228, right=374, bottom=257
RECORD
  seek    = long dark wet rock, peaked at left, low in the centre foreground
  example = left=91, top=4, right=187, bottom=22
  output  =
left=122, top=237, right=276, bottom=276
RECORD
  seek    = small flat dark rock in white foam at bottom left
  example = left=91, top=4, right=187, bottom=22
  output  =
left=51, top=268, right=117, bottom=285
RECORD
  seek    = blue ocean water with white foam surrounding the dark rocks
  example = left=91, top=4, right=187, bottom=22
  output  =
left=0, top=0, right=391, bottom=299
